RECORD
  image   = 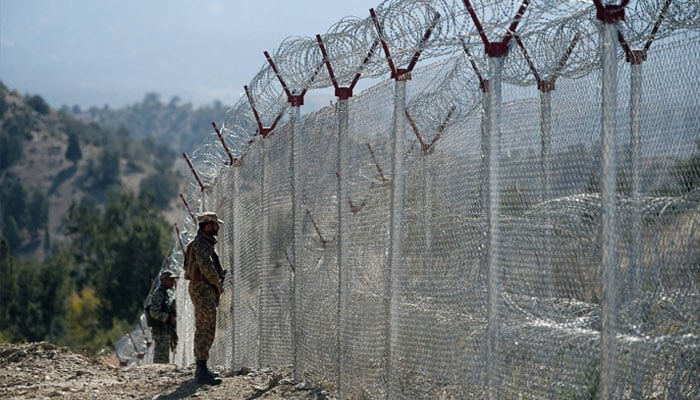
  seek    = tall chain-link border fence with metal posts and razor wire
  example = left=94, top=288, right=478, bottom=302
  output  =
left=131, top=0, right=700, bottom=399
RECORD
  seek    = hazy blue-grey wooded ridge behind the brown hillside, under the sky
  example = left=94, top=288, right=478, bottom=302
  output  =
left=62, top=93, right=228, bottom=153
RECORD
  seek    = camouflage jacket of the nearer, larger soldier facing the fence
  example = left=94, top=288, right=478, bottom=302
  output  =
left=185, top=231, right=224, bottom=291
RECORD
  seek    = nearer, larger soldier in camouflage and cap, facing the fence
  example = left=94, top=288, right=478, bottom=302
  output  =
left=185, top=212, right=225, bottom=385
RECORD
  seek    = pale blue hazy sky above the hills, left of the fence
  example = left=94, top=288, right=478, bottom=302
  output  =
left=0, top=0, right=381, bottom=108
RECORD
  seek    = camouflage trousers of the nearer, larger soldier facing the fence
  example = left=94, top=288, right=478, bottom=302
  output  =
left=189, top=282, right=218, bottom=361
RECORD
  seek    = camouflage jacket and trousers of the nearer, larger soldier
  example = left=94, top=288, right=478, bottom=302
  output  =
left=185, top=230, right=224, bottom=361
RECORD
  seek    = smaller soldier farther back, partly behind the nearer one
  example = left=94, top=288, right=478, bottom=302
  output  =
left=146, top=270, right=177, bottom=364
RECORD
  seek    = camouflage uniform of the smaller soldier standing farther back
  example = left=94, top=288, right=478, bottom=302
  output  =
left=146, top=287, right=176, bottom=364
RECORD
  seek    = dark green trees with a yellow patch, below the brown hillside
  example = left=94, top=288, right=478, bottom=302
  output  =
left=0, top=192, right=172, bottom=354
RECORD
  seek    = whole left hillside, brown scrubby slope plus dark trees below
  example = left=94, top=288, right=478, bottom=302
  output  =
left=0, top=83, right=184, bottom=352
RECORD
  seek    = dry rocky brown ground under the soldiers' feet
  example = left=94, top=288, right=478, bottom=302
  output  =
left=0, top=342, right=336, bottom=400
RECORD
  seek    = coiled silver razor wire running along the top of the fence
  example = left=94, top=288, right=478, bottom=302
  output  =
left=186, top=0, right=700, bottom=190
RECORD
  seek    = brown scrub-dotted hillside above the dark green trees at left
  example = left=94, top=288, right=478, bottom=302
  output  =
left=0, top=82, right=183, bottom=259
